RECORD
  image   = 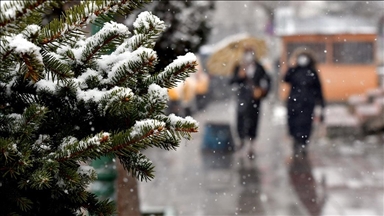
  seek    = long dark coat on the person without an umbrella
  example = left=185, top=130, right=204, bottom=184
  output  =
left=284, top=66, right=324, bottom=144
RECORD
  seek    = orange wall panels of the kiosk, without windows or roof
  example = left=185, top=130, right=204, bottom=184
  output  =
left=279, top=35, right=378, bottom=102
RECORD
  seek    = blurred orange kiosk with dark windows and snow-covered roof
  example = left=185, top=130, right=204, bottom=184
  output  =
left=275, top=7, right=380, bottom=102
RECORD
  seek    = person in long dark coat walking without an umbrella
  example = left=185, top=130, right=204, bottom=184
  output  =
left=284, top=49, right=325, bottom=155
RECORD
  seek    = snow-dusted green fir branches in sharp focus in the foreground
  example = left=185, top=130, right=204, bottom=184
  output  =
left=0, top=0, right=197, bottom=215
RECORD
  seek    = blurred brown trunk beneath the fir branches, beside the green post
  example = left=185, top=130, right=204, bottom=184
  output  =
left=116, top=159, right=141, bottom=216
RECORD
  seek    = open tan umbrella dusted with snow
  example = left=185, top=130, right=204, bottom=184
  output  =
left=207, top=35, right=267, bottom=76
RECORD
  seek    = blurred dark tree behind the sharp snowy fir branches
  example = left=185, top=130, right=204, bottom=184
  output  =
left=125, top=0, right=215, bottom=68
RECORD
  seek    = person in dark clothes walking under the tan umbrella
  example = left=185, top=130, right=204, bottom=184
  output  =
left=230, top=48, right=271, bottom=159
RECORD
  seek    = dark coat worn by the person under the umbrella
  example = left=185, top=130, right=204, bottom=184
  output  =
left=230, top=62, right=271, bottom=139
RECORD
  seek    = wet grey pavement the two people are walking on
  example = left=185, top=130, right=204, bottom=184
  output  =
left=139, top=98, right=384, bottom=216
